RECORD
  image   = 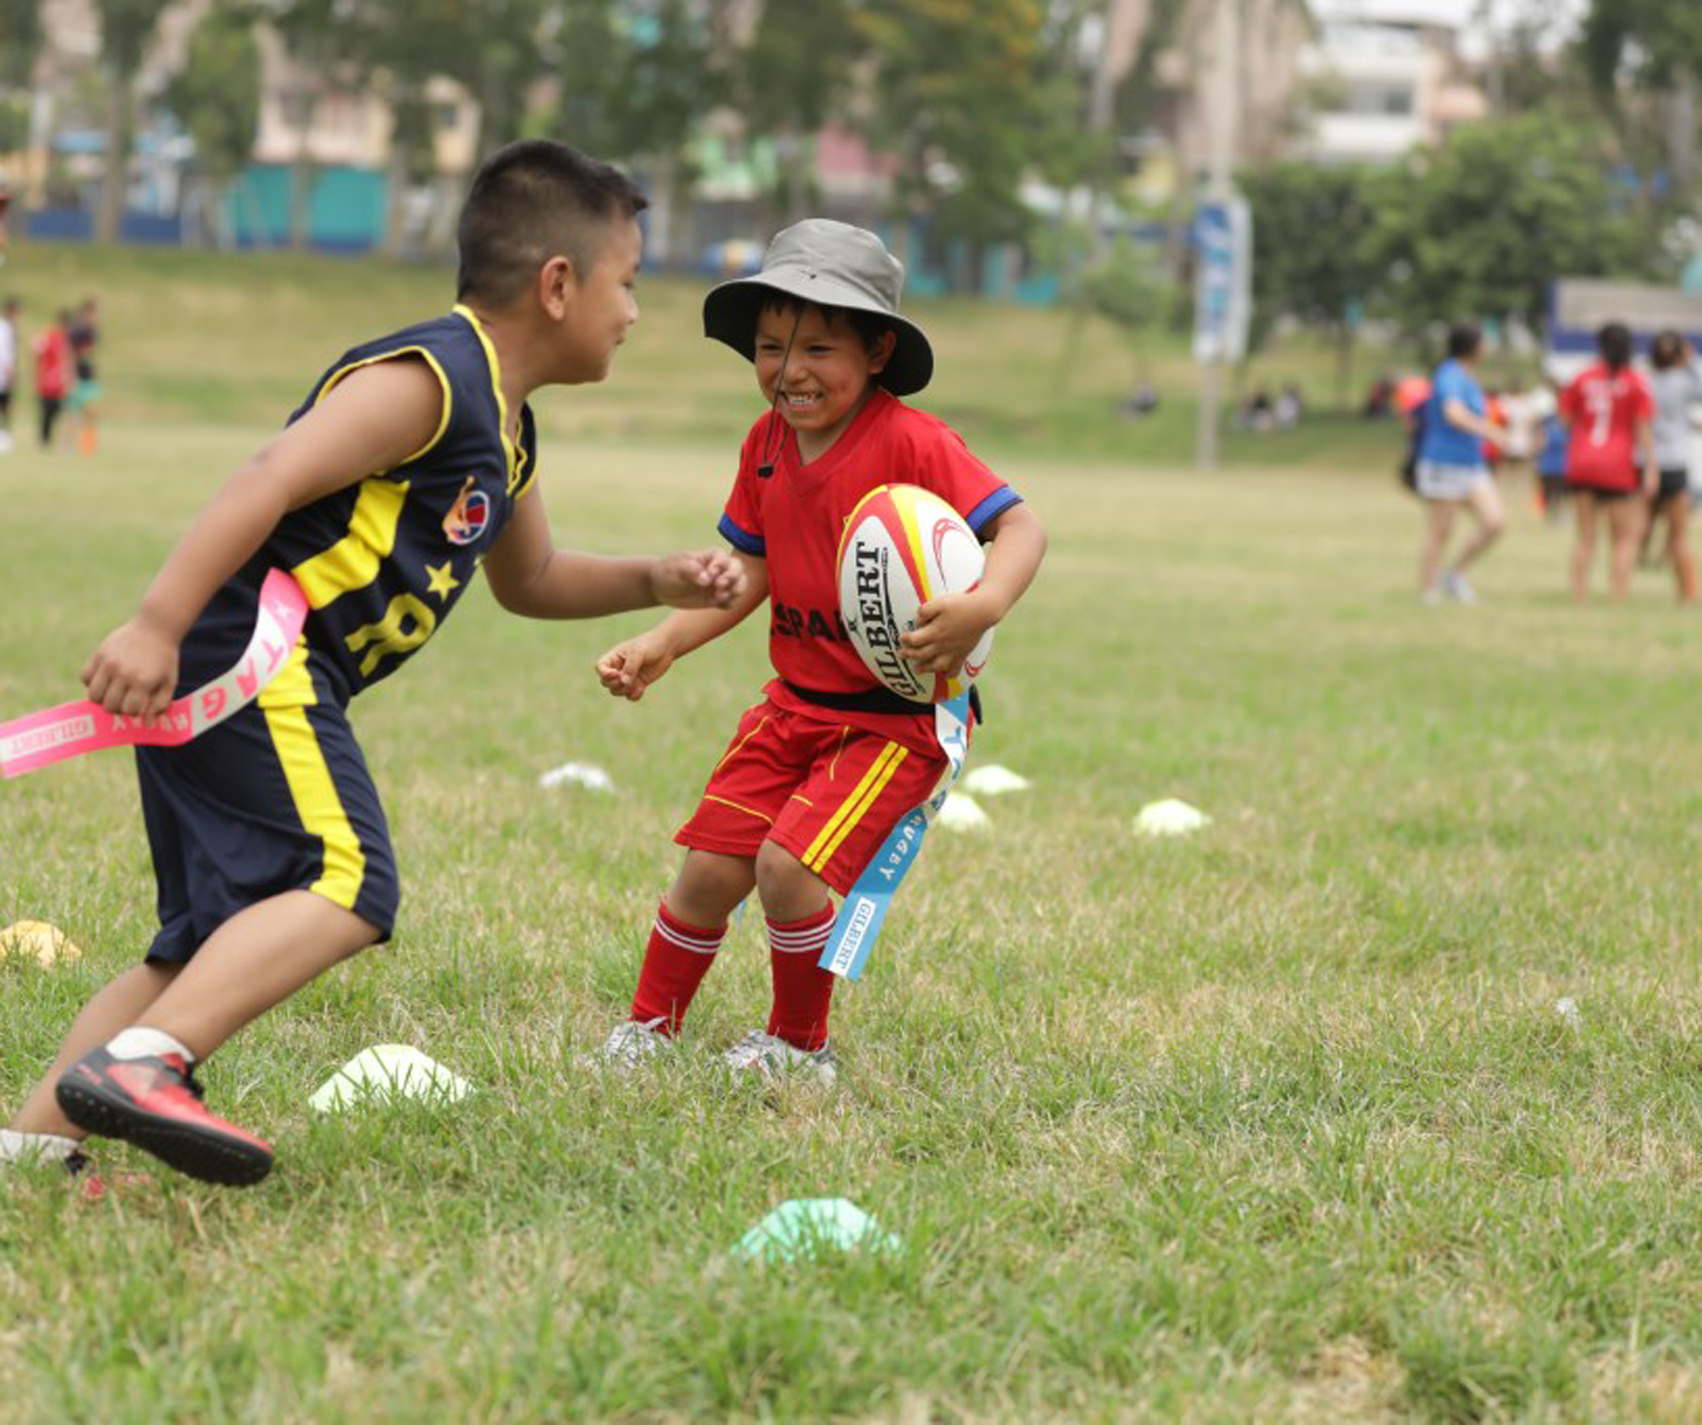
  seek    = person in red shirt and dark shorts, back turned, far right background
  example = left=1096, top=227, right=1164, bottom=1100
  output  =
left=1561, top=322, right=1661, bottom=599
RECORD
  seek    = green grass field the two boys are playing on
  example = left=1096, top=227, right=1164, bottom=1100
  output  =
left=0, top=254, right=1702, bottom=1425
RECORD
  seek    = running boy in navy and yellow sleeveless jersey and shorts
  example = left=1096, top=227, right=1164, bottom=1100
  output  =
left=0, top=141, right=744, bottom=1185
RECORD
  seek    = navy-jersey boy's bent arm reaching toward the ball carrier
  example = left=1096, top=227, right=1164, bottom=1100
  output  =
left=485, top=487, right=744, bottom=618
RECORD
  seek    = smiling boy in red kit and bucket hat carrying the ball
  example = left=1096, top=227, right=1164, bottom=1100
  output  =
left=596, top=218, right=1045, bottom=1083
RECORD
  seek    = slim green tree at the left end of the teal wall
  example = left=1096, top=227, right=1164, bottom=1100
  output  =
left=165, top=3, right=260, bottom=242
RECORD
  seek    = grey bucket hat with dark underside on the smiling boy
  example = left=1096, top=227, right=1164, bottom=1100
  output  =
left=703, top=218, right=934, bottom=395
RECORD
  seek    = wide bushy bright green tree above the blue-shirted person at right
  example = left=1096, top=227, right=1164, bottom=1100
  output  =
left=1368, top=114, right=1646, bottom=334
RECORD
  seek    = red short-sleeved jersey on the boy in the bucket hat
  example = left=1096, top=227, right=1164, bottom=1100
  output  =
left=720, top=386, right=1021, bottom=751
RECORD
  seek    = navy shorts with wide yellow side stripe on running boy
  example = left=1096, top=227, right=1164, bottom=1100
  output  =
left=136, top=642, right=398, bottom=964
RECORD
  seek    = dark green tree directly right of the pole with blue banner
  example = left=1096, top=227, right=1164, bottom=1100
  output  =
left=1239, top=162, right=1387, bottom=407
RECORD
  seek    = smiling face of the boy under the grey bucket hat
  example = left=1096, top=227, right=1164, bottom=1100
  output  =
left=756, top=305, right=895, bottom=460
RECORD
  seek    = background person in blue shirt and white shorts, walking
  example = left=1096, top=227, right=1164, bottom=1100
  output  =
left=1414, top=322, right=1506, bottom=604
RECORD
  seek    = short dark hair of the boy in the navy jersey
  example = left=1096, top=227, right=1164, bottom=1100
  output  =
left=456, top=138, right=648, bottom=306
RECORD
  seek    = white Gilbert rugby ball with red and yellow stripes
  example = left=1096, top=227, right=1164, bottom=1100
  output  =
left=839, top=485, right=992, bottom=703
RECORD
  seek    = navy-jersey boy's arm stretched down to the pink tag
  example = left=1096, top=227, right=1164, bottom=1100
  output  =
left=83, top=359, right=443, bottom=717
